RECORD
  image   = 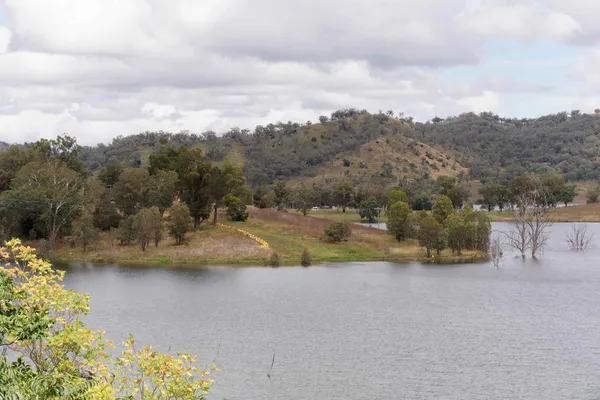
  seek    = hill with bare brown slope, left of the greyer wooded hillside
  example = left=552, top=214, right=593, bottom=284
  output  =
left=76, top=109, right=468, bottom=186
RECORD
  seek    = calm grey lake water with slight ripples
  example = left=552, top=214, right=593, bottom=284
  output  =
left=59, top=224, right=600, bottom=400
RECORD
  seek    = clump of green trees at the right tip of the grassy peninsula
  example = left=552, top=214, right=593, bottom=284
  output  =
left=387, top=191, right=491, bottom=257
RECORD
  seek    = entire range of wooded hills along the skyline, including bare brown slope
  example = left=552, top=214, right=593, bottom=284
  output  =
left=56, top=109, right=600, bottom=186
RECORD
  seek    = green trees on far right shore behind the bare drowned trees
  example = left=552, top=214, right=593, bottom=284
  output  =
left=479, top=173, right=577, bottom=211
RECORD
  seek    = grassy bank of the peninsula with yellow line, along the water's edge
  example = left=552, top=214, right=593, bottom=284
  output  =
left=57, top=209, right=481, bottom=265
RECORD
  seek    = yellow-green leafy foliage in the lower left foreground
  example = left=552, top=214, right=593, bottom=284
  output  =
left=0, top=240, right=214, bottom=400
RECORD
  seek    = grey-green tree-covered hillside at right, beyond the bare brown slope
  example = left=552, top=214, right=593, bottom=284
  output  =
left=402, top=110, right=600, bottom=180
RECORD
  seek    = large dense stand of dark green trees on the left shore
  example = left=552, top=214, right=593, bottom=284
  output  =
left=0, top=136, right=251, bottom=250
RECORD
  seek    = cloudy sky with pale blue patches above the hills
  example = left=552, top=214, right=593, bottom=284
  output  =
left=0, top=0, right=600, bottom=144
